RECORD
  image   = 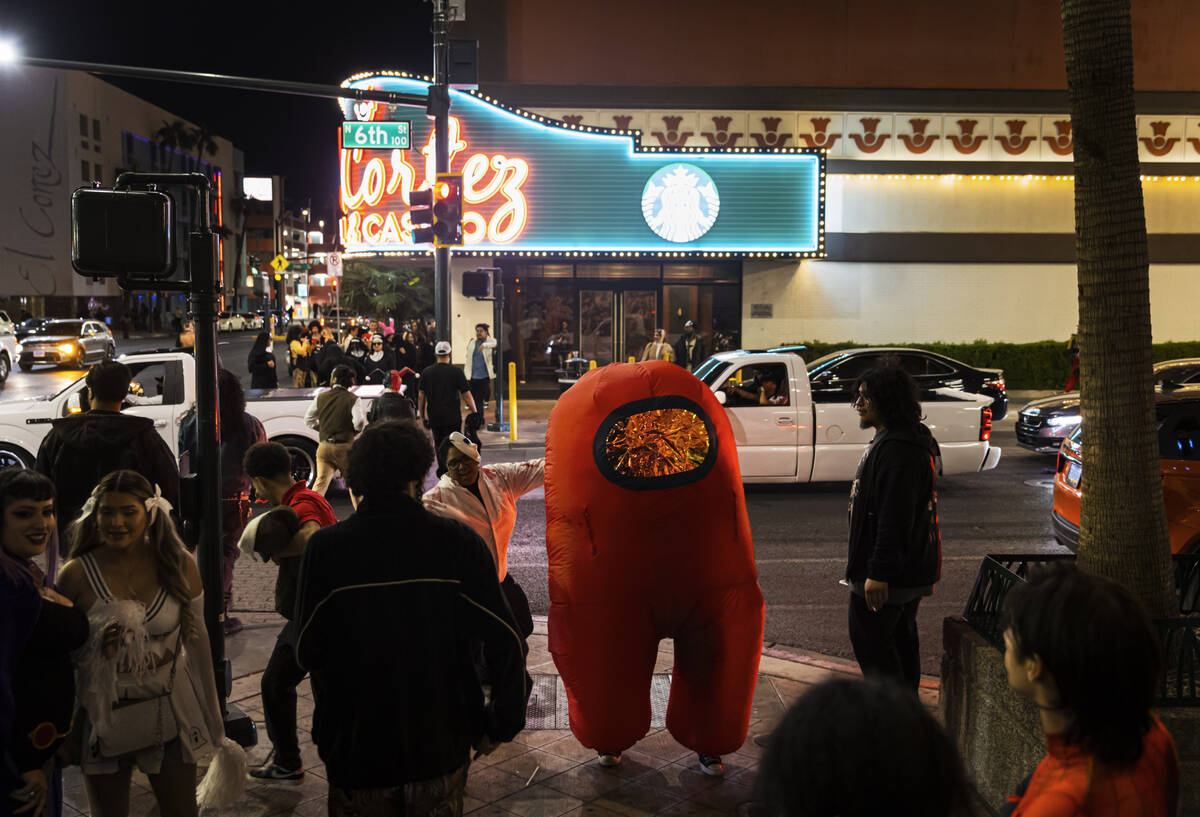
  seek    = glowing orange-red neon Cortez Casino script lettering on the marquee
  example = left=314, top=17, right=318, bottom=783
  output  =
left=340, top=116, right=529, bottom=250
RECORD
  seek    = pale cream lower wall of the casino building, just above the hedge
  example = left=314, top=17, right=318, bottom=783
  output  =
left=742, top=260, right=1200, bottom=348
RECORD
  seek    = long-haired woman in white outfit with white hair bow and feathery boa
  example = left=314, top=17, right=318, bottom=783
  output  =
left=60, top=470, right=245, bottom=817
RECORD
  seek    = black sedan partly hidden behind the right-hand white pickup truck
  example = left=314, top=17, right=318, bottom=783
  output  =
left=808, top=348, right=1008, bottom=420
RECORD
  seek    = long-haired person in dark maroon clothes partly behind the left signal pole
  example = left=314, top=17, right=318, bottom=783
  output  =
left=179, top=368, right=266, bottom=636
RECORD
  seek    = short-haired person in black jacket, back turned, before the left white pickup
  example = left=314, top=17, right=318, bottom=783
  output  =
left=34, top=360, right=179, bottom=533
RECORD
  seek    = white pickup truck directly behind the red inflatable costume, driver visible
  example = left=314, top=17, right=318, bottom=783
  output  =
left=696, top=352, right=1001, bottom=482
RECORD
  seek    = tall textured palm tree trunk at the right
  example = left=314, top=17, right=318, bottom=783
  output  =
left=1062, top=0, right=1177, bottom=615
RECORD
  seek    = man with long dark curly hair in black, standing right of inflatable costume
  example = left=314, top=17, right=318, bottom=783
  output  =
left=846, top=367, right=942, bottom=692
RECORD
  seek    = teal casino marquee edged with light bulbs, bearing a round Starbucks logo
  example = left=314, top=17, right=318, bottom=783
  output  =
left=338, top=72, right=826, bottom=259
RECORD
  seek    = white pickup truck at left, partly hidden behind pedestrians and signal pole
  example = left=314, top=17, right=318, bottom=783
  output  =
left=0, top=352, right=383, bottom=482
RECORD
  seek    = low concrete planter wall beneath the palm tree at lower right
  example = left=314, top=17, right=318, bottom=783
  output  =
left=941, top=618, right=1200, bottom=817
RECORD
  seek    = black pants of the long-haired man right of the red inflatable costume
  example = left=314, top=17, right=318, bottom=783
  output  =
left=850, top=593, right=920, bottom=692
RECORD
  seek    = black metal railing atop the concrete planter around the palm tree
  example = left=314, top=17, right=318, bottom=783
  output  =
left=962, top=553, right=1200, bottom=707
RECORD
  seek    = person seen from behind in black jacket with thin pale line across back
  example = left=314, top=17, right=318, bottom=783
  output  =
left=296, top=420, right=530, bottom=817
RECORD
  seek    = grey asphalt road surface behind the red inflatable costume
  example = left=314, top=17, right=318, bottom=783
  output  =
left=0, top=323, right=1062, bottom=674
